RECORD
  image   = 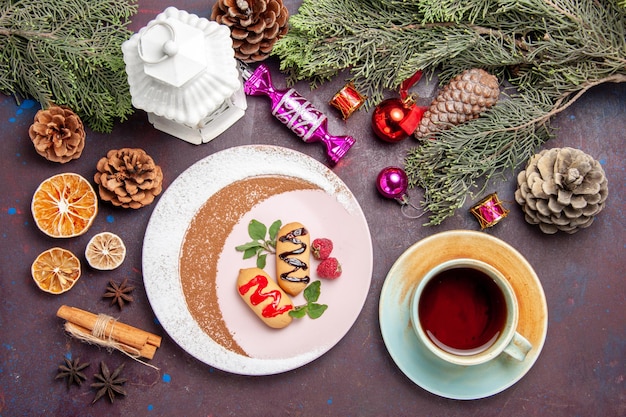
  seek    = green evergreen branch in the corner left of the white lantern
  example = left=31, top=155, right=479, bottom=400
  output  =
left=0, top=0, right=137, bottom=132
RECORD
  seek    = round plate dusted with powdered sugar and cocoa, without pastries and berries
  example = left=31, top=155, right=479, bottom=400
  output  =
left=143, top=145, right=372, bottom=375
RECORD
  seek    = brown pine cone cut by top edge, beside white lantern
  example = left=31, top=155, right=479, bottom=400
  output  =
left=211, top=0, right=289, bottom=63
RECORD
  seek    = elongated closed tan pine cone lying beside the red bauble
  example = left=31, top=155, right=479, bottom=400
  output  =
left=414, top=68, right=500, bottom=139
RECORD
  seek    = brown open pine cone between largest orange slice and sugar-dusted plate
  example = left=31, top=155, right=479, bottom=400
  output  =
left=94, top=148, right=163, bottom=209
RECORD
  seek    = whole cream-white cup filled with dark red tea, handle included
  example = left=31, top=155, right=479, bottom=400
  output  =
left=411, top=258, right=532, bottom=366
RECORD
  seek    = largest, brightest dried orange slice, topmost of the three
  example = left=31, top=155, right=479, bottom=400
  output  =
left=31, top=172, right=98, bottom=237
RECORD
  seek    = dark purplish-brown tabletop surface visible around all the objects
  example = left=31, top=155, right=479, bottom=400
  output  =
left=0, top=0, right=626, bottom=417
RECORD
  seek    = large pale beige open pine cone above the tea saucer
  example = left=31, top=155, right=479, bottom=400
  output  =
left=515, top=148, right=609, bottom=234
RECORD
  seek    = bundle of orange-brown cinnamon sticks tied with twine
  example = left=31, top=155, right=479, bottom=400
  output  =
left=57, top=306, right=161, bottom=369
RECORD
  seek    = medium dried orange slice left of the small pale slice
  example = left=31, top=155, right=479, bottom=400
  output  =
left=30, top=248, right=80, bottom=294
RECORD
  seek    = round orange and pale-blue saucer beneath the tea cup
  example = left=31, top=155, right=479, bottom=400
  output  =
left=379, top=230, right=548, bottom=400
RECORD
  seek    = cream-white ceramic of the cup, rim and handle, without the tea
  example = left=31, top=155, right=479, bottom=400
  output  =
left=411, top=258, right=532, bottom=366
